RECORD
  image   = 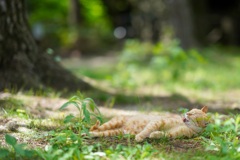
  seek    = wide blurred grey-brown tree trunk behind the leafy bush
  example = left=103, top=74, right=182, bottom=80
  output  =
left=103, top=0, right=196, bottom=48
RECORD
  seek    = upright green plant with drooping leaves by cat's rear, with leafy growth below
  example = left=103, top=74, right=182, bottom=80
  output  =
left=38, top=95, right=102, bottom=160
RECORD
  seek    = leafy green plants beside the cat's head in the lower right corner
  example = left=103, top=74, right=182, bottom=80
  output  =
left=203, top=115, right=240, bottom=159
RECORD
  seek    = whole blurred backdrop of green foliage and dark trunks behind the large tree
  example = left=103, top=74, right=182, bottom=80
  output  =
left=27, top=0, right=240, bottom=90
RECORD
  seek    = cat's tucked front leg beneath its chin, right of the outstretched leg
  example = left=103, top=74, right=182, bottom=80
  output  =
left=166, top=126, right=195, bottom=138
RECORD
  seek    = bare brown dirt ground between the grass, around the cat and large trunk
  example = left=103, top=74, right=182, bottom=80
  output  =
left=0, top=54, right=240, bottom=159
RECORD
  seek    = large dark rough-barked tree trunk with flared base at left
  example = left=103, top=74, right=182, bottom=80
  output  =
left=0, top=0, right=91, bottom=91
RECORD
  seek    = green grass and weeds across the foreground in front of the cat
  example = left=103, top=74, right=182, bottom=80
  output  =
left=0, top=96, right=240, bottom=160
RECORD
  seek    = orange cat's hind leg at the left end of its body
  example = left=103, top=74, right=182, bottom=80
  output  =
left=90, top=117, right=126, bottom=131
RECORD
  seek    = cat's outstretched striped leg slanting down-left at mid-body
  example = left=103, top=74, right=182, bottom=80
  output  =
left=135, top=121, right=163, bottom=142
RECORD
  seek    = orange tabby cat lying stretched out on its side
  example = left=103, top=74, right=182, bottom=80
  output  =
left=90, top=106, right=210, bottom=142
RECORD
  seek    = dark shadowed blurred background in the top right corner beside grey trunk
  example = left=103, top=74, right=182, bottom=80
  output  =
left=189, top=0, right=240, bottom=46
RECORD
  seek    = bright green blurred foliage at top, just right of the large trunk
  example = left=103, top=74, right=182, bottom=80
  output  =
left=27, top=0, right=112, bottom=55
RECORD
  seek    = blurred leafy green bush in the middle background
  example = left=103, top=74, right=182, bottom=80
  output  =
left=113, top=40, right=206, bottom=85
